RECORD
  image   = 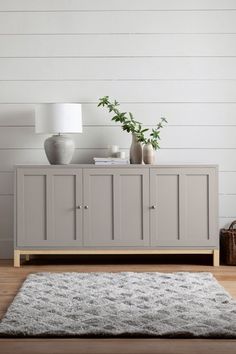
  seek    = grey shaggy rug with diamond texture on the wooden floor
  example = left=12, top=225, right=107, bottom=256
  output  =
left=0, top=272, right=236, bottom=338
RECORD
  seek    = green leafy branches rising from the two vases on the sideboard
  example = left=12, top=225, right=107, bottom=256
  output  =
left=98, top=96, right=167, bottom=150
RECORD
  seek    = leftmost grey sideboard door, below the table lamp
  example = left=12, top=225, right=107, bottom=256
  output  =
left=16, top=168, right=83, bottom=247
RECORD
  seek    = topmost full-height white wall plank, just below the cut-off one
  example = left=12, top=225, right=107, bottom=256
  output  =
left=0, top=10, right=236, bottom=34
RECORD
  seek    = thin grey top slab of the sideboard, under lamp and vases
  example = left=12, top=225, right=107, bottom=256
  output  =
left=15, top=164, right=218, bottom=169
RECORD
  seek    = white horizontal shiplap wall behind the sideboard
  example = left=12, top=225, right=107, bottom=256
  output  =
left=0, top=0, right=236, bottom=258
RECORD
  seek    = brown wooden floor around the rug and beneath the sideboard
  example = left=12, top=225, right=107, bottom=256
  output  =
left=0, top=257, right=236, bottom=354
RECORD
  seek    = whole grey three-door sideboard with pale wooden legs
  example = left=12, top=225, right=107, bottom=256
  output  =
left=14, top=165, right=219, bottom=267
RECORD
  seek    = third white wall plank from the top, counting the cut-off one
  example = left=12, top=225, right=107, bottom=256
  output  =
left=0, top=34, right=236, bottom=57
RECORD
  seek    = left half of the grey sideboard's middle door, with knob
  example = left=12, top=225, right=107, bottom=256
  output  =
left=84, top=170, right=114, bottom=246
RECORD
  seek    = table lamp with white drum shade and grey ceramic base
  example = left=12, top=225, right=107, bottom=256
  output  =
left=35, top=103, right=82, bottom=165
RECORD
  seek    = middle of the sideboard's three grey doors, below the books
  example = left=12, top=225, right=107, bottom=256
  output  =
left=83, top=168, right=149, bottom=248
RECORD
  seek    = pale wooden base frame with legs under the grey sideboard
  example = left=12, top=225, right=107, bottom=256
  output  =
left=14, top=249, right=220, bottom=267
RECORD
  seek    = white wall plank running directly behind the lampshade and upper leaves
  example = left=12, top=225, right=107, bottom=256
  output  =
left=0, top=103, right=236, bottom=127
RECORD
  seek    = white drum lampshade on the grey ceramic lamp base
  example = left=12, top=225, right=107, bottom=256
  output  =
left=35, top=103, right=83, bottom=134
